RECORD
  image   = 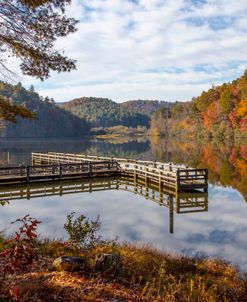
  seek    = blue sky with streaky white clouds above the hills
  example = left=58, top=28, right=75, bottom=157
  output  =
left=4, top=0, right=247, bottom=102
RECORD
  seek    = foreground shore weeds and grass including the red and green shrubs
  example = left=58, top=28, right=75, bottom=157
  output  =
left=0, top=213, right=247, bottom=302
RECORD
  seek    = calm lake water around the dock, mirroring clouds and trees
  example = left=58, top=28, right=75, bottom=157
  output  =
left=0, top=139, right=247, bottom=270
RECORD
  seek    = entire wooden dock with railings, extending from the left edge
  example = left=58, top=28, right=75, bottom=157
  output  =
left=0, top=152, right=208, bottom=192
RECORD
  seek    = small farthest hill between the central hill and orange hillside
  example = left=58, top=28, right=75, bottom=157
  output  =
left=121, top=100, right=172, bottom=117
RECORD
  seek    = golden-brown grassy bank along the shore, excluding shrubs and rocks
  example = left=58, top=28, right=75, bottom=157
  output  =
left=0, top=238, right=247, bottom=301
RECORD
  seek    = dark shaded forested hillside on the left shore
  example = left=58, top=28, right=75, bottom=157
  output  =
left=0, top=82, right=89, bottom=137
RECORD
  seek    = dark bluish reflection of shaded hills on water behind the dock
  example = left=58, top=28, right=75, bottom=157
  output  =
left=0, top=138, right=152, bottom=165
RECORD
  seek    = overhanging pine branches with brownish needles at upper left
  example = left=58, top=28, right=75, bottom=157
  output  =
left=0, top=0, right=77, bottom=122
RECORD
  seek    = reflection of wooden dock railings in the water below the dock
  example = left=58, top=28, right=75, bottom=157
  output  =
left=0, top=177, right=208, bottom=233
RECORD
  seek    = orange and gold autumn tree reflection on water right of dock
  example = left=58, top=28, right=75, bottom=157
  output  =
left=151, top=139, right=247, bottom=199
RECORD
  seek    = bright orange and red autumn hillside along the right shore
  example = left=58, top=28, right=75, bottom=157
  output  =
left=151, top=70, right=247, bottom=138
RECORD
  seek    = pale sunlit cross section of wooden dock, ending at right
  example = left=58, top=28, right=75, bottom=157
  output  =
left=32, top=152, right=208, bottom=192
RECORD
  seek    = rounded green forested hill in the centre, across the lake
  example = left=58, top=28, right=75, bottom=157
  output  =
left=61, top=97, right=150, bottom=127
